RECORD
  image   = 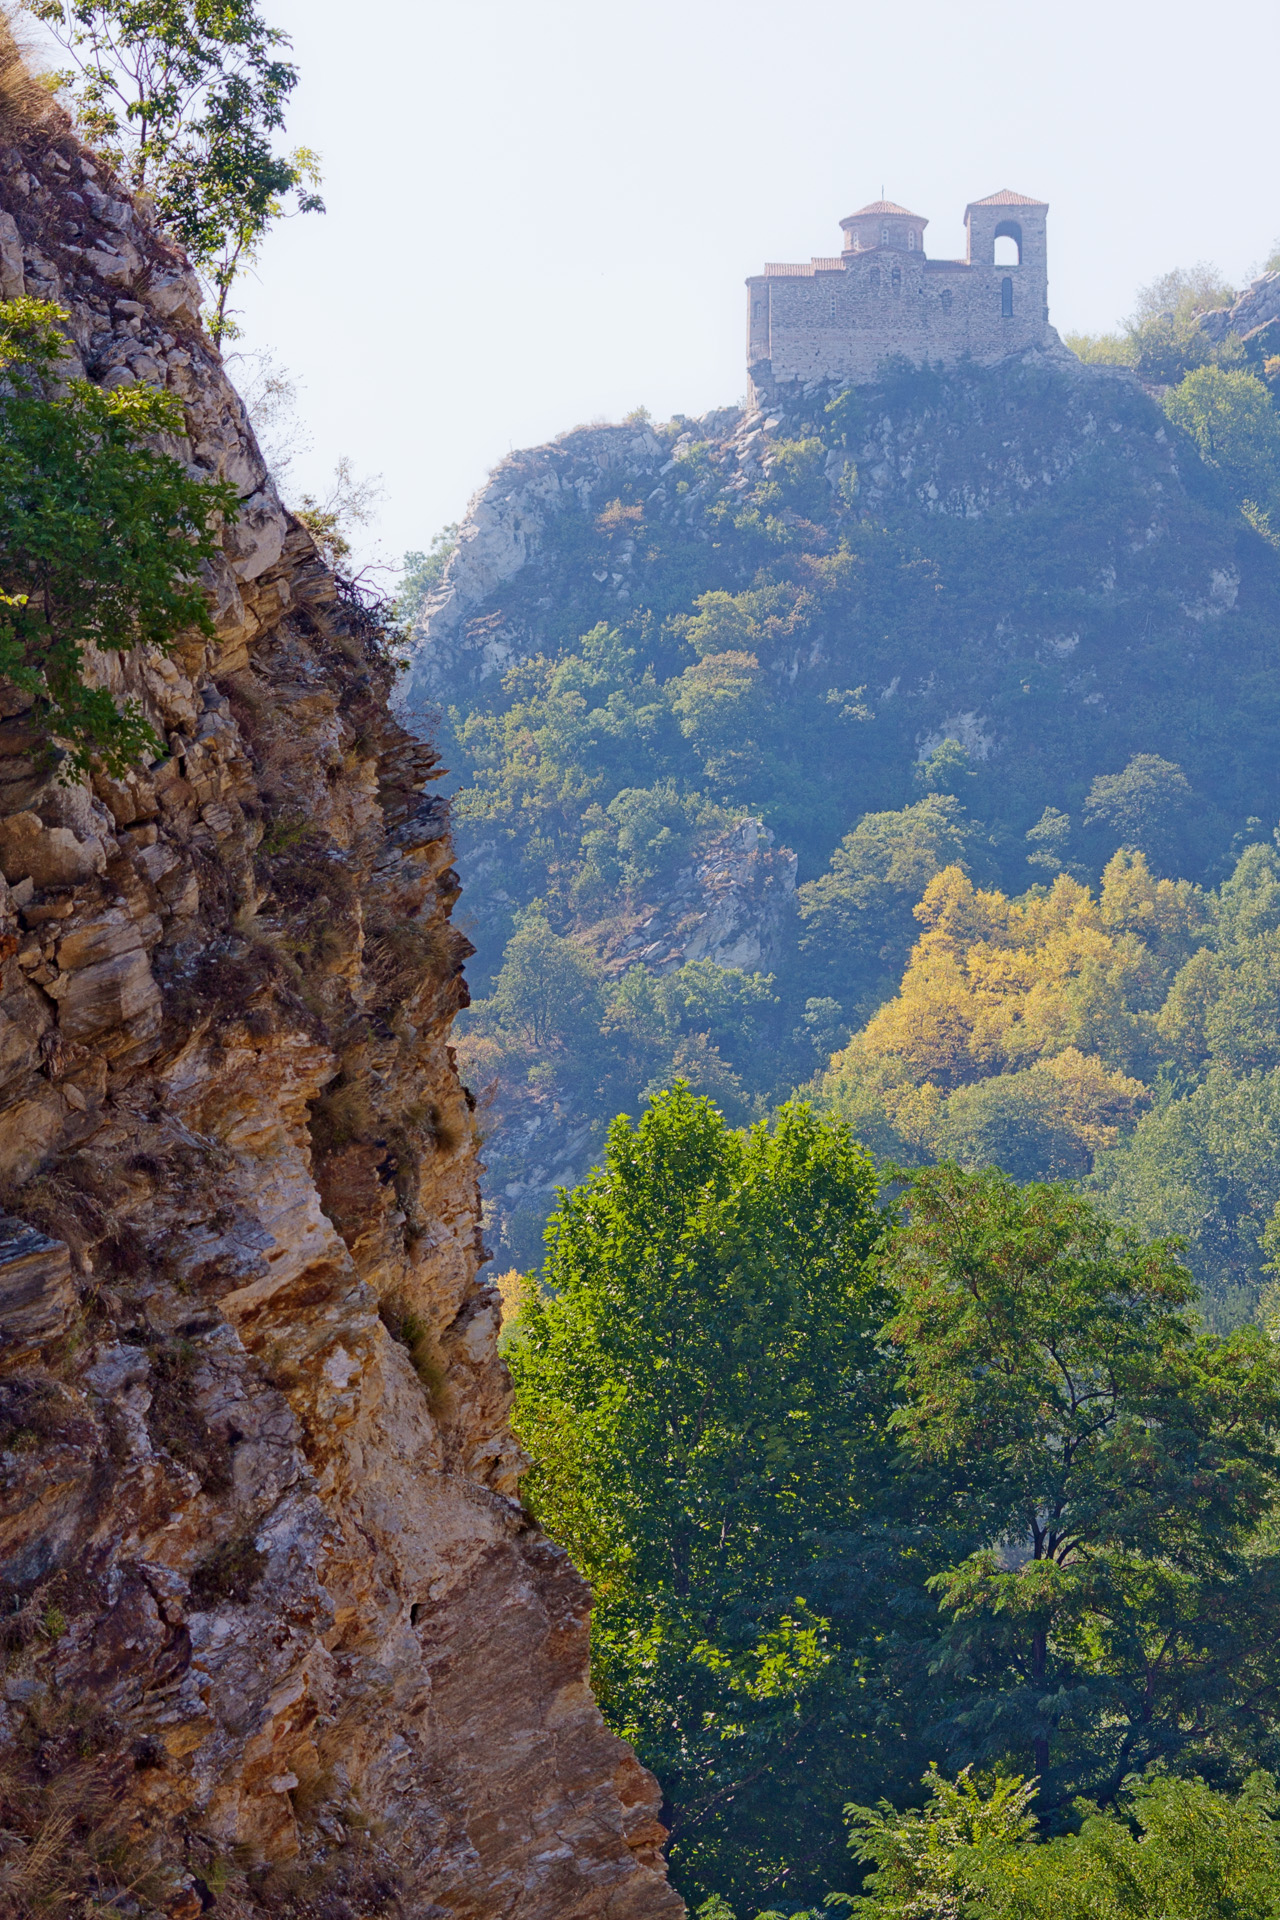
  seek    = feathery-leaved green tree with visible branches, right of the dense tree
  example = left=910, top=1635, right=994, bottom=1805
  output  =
left=887, top=1165, right=1280, bottom=1816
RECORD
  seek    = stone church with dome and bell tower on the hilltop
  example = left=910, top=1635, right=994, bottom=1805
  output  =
left=747, top=186, right=1057, bottom=388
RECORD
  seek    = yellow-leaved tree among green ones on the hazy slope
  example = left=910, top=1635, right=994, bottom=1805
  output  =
left=816, top=849, right=1211, bottom=1179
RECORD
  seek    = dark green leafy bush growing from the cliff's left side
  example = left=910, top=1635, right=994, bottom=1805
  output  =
left=0, top=300, right=238, bottom=772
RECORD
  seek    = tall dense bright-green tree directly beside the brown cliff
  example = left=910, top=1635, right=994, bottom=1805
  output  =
left=509, top=1087, right=892, bottom=1897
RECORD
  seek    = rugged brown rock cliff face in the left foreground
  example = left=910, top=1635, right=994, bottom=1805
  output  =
left=0, top=93, right=683, bottom=1920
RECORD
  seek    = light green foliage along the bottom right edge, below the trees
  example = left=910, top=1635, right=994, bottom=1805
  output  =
left=835, top=1770, right=1280, bottom=1920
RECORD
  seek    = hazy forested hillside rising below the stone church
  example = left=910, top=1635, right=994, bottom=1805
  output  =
left=409, top=263, right=1280, bottom=1317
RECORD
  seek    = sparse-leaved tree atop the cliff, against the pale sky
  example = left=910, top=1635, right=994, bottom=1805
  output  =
left=25, top=0, right=324, bottom=338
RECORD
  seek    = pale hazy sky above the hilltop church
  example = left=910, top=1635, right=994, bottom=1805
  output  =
left=122, top=0, right=1280, bottom=555
